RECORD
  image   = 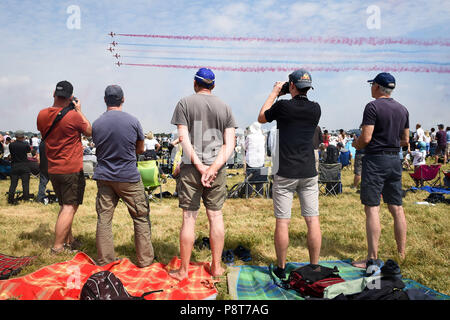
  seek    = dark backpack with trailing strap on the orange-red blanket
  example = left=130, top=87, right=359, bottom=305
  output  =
left=80, top=271, right=163, bottom=300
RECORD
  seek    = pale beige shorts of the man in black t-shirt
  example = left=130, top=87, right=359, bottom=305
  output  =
left=272, top=175, right=319, bottom=219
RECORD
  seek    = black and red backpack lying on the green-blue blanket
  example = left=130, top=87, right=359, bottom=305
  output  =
left=286, top=264, right=345, bottom=298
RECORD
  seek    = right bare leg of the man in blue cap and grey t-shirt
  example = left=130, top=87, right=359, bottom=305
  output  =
left=206, top=209, right=225, bottom=277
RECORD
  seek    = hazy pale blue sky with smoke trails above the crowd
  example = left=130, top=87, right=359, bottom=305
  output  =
left=0, top=0, right=450, bottom=133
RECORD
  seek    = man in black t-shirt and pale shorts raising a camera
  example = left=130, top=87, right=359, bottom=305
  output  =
left=258, top=69, right=322, bottom=279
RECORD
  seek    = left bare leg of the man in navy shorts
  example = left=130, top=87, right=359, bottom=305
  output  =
left=353, top=206, right=381, bottom=268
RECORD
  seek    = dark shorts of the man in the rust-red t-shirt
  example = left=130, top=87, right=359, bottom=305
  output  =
left=49, top=171, right=86, bottom=206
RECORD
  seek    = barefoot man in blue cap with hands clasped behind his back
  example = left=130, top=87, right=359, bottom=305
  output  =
left=170, top=68, right=236, bottom=280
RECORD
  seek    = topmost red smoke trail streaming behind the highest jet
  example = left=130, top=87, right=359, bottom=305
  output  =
left=116, top=33, right=450, bottom=47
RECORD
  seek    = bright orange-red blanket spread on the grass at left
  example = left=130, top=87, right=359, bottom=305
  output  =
left=0, top=252, right=217, bottom=300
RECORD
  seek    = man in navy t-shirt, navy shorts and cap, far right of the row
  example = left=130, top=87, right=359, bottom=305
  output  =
left=353, top=72, right=409, bottom=268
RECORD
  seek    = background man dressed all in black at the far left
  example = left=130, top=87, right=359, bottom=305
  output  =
left=8, top=130, right=31, bottom=204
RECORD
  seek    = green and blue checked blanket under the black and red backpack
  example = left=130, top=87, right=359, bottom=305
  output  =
left=227, top=260, right=450, bottom=300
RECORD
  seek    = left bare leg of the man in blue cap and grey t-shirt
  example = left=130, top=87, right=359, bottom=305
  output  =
left=169, top=210, right=198, bottom=281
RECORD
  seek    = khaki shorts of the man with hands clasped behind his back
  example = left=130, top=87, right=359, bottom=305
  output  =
left=177, top=163, right=227, bottom=211
